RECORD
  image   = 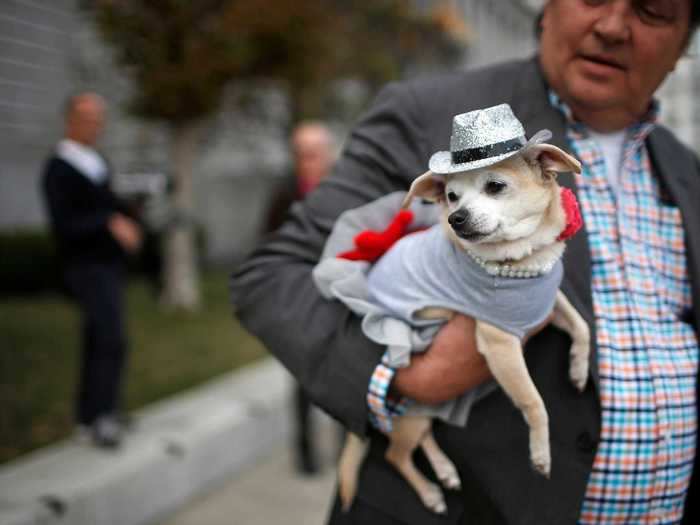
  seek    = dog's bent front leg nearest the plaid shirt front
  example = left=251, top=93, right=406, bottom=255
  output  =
left=552, top=290, right=591, bottom=392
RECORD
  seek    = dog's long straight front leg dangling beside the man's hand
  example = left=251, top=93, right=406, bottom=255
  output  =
left=476, top=321, right=552, bottom=477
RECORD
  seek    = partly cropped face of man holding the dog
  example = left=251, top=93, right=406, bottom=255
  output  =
left=540, top=0, right=699, bottom=131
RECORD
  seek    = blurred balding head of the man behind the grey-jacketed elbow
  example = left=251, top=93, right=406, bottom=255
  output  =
left=291, top=122, right=335, bottom=193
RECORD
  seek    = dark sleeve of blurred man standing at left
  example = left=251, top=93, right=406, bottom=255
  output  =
left=44, top=162, right=112, bottom=241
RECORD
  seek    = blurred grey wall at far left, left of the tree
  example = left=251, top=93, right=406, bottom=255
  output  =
left=0, top=0, right=76, bottom=226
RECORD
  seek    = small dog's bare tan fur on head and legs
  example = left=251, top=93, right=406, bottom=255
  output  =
left=339, top=144, right=590, bottom=514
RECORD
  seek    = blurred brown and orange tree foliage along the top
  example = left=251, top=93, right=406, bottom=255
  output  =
left=93, top=0, right=467, bottom=123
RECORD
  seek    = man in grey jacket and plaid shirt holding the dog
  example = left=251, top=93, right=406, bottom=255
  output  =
left=232, top=0, right=700, bottom=524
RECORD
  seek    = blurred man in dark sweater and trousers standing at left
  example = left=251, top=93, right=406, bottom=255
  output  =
left=42, top=93, right=142, bottom=448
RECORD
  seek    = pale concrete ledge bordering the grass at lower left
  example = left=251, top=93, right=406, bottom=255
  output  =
left=0, top=359, right=306, bottom=525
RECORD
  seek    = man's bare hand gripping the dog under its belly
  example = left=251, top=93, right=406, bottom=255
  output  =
left=391, top=314, right=551, bottom=405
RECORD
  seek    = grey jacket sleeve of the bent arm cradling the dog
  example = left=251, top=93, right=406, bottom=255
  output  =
left=231, top=84, right=427, bottom=435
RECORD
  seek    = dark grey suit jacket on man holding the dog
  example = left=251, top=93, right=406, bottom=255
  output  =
left=231, top=55, right=700, bottom=525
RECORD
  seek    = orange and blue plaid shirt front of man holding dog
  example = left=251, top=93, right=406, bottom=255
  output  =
left=552, top=95, right=698, bottom=525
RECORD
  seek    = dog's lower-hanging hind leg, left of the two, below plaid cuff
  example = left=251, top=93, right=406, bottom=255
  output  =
left=386, top=416, right=447, bottom=514
